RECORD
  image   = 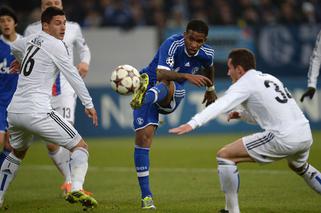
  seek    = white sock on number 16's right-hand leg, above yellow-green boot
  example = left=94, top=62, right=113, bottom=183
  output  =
left=70, top=148, right=89, bottom=192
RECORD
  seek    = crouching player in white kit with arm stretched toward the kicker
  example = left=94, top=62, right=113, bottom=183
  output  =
left=169, top=49, right=321, bottom=213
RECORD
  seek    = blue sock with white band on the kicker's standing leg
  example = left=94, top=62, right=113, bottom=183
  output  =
left=134, top=146, right=152, bottom=198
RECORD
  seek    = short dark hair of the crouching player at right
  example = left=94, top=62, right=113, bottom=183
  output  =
left=228, top=48, right=256, bottom=71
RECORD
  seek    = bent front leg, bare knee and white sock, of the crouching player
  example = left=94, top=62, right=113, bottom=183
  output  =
left=216, top=139, right=253, bottom=213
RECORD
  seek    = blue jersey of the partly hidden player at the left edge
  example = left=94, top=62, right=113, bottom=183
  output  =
left=0, top=39, right=19, bottom=108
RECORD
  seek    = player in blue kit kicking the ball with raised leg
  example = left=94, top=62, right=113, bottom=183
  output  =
left=130, top=20, right=216, bottom=209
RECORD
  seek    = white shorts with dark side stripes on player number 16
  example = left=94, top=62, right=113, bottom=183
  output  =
left=8, top=111, right=82, bottom=151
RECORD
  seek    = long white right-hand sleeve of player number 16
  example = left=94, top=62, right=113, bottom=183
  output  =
left=53, top=41, right=94, bottom=109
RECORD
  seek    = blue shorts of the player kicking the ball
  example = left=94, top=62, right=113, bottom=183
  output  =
left=133, top=82, right=185, bottom=130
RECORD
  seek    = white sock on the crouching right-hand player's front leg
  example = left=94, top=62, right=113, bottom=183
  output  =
left=216, top=157, right=240, bottom=213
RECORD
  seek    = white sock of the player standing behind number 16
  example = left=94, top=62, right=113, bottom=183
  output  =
left=49, top=146, right=71, bottom=182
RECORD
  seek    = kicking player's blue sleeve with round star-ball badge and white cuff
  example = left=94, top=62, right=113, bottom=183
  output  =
left=157, top=39, right=175, bottom=70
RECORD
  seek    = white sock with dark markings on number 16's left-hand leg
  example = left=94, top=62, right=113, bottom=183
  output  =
left=0, top=153, right=21, bottom=201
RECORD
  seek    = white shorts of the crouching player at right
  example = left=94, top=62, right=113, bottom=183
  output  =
left=242, top=131, right=312, bottom=168
